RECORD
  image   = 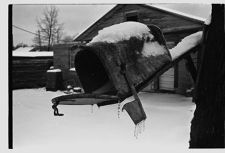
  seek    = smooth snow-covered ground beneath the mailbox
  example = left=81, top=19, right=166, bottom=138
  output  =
left=13, top=88, right=195, bottom=152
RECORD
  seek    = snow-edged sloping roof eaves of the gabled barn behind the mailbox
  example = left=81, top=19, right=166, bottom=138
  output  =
left=74, top=4, right=205, bottom=41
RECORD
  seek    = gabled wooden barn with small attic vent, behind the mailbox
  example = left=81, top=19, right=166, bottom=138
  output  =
left=54, top=4, right=204, bottom=94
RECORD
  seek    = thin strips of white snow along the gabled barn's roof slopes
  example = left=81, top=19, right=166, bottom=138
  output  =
left=73, top=4, right=205, bottom=40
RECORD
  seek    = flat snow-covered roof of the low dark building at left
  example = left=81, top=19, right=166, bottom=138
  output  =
left=13, top=51, right=53, bottom=57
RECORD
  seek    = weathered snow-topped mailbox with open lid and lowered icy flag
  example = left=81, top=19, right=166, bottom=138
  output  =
left=52, top=22, right=171, bottom=124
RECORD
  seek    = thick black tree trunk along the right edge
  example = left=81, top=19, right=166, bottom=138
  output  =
left=190, top=4, right=225, bottom=148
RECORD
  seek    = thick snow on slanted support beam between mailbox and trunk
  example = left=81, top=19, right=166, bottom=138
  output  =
left=170, top=31, right=203, bottom=60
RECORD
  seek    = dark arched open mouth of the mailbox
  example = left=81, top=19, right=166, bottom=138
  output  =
left=75, top=49, right=115, bottom=94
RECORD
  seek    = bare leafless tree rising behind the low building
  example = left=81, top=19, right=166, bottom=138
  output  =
left=37, top=6, right=63, bottom=51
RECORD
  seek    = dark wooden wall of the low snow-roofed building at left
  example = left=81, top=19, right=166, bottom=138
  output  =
left=12, top=57, right=53, bottom=89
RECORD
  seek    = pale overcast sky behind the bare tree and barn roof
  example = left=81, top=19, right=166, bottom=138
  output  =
left=13, top=4, right=211, bottom=45
